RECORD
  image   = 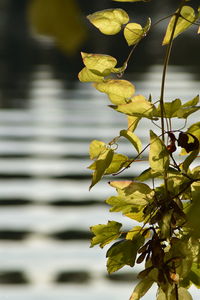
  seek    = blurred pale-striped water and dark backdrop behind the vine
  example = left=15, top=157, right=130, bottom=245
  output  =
left=0, top=0, right=200, bottom=300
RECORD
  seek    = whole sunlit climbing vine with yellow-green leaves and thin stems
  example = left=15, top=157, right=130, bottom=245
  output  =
left=78, top=0, right=200, bottom=300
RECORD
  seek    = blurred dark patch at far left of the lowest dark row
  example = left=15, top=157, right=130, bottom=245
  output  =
left=0, top=270, right=29, bottom=284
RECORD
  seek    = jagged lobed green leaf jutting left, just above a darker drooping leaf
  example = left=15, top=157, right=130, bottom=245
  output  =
left=90, top=221, right=122, bottom=248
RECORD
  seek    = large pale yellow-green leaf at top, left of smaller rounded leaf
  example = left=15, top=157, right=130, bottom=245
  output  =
left=87, top=8, right=129, bottom=35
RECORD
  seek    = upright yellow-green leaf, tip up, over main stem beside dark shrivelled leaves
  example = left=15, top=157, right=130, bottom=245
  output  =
left=149, top=130, right=169, bottom=174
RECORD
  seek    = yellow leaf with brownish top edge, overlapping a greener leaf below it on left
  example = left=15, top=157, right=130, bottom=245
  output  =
left=81, top=52, right=117, bottom=76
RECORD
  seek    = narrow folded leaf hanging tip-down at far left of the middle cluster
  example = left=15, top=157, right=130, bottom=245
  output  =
left=89, top=149, right=114, bottom=189
